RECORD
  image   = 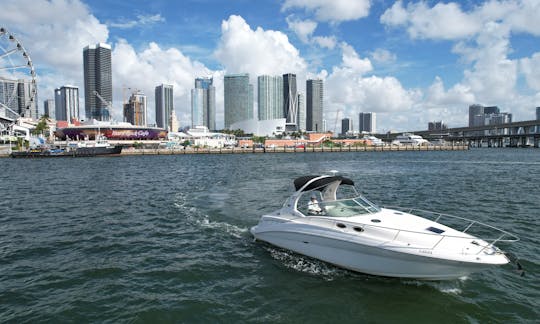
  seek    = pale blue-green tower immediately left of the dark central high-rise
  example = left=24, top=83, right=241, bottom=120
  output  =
left=257, top=75, right=285, bottom=120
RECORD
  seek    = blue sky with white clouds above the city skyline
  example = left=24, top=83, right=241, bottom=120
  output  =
left=0, top=0, right=540, bottom=132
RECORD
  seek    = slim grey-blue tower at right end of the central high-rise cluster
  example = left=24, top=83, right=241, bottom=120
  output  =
left=306, top=79, right=324, bottom=132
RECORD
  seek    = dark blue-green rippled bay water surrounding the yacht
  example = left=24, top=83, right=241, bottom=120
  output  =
left=0, top=149, right=540, bottom=323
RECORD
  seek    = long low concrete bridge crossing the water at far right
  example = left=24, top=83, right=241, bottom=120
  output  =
left=376, top=120, right=540, bottom=147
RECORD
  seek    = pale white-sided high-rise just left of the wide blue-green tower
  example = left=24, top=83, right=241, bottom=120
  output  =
left=191, top=78, right=216, bottom=130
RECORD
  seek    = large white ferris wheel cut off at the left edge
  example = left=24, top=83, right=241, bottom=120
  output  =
left=0, top=26, right=38, bottom=120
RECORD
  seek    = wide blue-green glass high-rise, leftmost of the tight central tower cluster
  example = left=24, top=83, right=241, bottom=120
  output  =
left=223, top=73, right=253, bottom=128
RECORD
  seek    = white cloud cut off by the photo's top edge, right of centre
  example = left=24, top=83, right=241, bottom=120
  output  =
left=282, top=0, right=371, bottom=23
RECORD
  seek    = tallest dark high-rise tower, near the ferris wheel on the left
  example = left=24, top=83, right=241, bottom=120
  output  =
left=83, top=43, right=113, bottom=121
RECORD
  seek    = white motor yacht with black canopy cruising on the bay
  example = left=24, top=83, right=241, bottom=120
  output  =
left=251, top=175, right=519, bottom=280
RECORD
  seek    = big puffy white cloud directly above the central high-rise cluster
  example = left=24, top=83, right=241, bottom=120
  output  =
left=214, top=15, right=307, bottom=76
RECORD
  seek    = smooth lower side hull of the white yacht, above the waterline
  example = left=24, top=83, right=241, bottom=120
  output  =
left=251, top=226, right=504, bottom=280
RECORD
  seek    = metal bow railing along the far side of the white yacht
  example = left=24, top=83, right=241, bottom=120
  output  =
left=384, top=206, right=519, bottom=253
